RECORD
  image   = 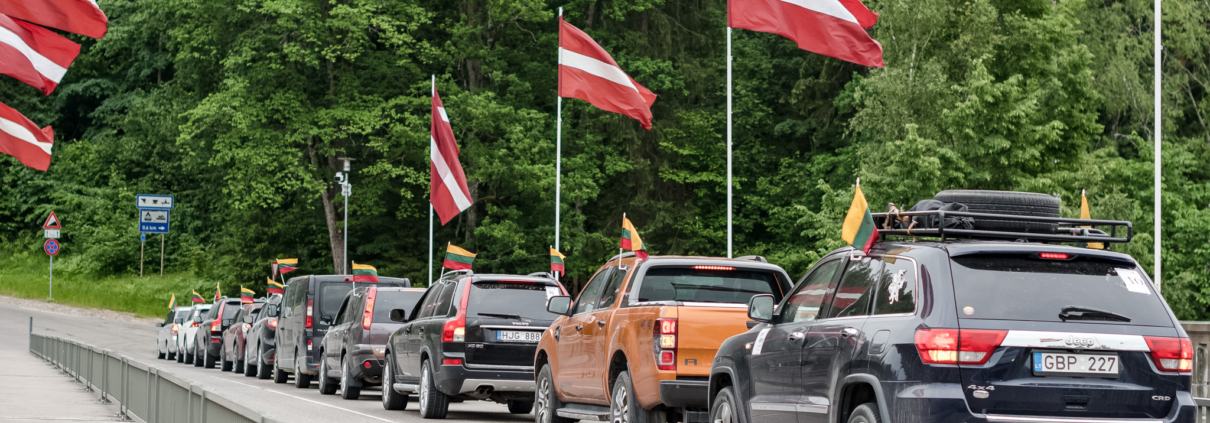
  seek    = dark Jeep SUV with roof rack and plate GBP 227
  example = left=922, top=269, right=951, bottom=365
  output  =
left=710, top=192, right=1195, bottom=423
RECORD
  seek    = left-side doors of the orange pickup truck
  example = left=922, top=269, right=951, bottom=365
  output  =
left=554, top=267, right=613, bottom=400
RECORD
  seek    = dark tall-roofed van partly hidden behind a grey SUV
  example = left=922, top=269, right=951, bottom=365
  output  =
left=273, top=274, right=411, bottom=388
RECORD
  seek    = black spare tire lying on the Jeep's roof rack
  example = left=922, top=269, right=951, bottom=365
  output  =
left=933, top=190, right=1059, bottom=233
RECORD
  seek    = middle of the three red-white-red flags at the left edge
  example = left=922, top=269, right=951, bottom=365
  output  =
left=0, top=15, right=80, bottom=94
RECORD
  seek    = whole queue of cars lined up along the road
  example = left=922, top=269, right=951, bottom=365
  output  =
left=148, top=191, right=1195, bottom=423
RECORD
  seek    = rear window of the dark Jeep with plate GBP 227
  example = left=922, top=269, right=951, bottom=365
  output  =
left=952, top=255, right=1172, bottom=328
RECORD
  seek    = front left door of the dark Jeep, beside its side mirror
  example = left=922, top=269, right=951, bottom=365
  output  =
left=749, top=256, right=845, bottom=423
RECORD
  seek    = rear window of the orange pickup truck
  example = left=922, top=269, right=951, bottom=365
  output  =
left=639, top=266, right=782, bottom=303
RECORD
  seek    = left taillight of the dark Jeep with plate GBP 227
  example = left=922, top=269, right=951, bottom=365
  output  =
left=916, top=329, right=1008, bottom=365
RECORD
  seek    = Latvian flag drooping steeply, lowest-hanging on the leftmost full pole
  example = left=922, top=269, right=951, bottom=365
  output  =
left=428, top=91, right=472, bottom=225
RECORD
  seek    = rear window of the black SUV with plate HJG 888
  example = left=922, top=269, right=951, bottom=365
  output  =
left=467, top=282, right=563, bottom=320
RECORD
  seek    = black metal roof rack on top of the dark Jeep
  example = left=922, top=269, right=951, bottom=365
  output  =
left=870, top=210, right=1134, bottom=244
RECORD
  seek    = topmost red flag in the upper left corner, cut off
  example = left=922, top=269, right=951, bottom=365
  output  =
left=0, top=0, right=109, bottom=39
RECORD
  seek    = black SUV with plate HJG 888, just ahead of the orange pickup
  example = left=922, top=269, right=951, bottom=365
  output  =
left=382, top=271, right=567, bottom=418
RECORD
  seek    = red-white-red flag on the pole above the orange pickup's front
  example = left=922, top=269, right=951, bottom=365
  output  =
left=559, top=17, right=656, bottom=131
